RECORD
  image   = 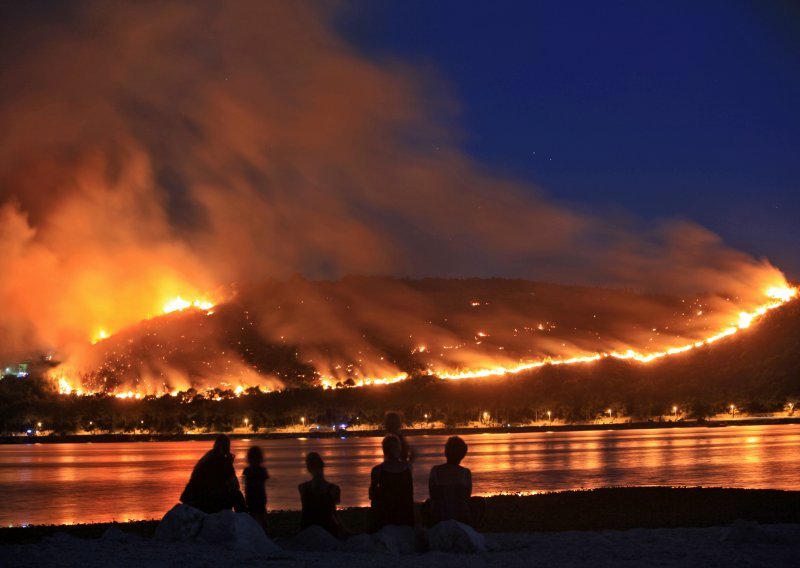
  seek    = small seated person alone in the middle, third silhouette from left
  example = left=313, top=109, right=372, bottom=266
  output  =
left=297, top=452, right=345, bottom=538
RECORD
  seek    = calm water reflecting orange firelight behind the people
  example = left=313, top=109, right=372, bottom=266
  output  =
left=0, top=424, right=800, bottom=526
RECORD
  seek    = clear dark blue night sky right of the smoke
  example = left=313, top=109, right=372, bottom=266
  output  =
left=340, top=0, right=800, bottom=279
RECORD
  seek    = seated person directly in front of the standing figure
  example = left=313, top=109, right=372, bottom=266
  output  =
left=369, top=435, right=414, bottom=531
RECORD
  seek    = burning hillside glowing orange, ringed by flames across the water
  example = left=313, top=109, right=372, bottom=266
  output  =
left=48, top=277, right=795, bottom=396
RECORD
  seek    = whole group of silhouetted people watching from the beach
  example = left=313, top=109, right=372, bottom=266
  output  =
left=181, top=412, right=482, bottom=537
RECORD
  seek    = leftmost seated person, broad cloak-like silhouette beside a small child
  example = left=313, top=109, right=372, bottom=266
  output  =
left=181, top=434, right=245, bottom=513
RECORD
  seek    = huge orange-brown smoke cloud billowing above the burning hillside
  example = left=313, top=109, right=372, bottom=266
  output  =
left=0, top=0, right=785, bottom=390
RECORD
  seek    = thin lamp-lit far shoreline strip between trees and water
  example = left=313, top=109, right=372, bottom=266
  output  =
left=0, top=417, right=800, bottom=445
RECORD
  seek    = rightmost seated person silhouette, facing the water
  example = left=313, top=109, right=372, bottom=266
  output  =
left=423, top=436, right=483, bottom=526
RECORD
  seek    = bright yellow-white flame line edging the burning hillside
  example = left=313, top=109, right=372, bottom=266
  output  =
left=58, top=287, right=798, bottom=399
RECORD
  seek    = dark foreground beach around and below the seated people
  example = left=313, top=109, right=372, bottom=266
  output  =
left=0, top=487, right=800, bottom=567
